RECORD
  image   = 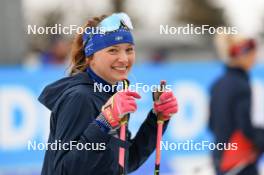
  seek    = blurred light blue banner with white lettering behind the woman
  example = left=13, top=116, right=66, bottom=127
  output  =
left=0, top=61, right=264, bottom=175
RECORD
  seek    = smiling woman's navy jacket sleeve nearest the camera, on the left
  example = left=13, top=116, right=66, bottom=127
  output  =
left=53, top=93, right=110, bottom=175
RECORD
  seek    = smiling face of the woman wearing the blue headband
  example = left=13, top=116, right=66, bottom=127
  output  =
left=90, top=43, right=135, bottom=84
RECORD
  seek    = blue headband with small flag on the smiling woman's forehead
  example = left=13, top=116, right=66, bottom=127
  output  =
left=83, top=26, right=134, bottom=57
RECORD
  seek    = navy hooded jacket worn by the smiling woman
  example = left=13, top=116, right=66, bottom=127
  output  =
left=39, top=72, right=168, bottom=175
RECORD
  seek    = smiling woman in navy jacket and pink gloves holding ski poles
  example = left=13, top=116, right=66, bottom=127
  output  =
left=39, top=13, right=178, bottom=175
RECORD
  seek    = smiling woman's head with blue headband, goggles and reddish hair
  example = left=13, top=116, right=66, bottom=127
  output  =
left=70, top=13, right=135, bottom=80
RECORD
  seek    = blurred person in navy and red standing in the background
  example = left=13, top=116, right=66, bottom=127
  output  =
left=209, top=35, right=264, bottom=175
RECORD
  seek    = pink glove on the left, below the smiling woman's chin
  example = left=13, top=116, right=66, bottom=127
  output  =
left=102, top=91, right=141, bottom=128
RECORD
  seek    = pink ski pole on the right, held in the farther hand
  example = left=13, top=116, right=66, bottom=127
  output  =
left=153, top=80, right=166, bottom=175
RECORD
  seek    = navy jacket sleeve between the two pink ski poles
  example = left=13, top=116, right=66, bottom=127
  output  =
left=128, top=110, right=169, bottom=173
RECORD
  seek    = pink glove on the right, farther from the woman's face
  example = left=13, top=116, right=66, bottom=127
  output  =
left=154, top=91, right=178, bottom=121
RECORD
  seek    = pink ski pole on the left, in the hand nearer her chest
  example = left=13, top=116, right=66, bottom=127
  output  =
left=119, top=79, right=129, bottom=175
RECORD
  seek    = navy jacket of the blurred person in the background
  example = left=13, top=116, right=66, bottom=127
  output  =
left=209, top=67, right=264, bottom=175
